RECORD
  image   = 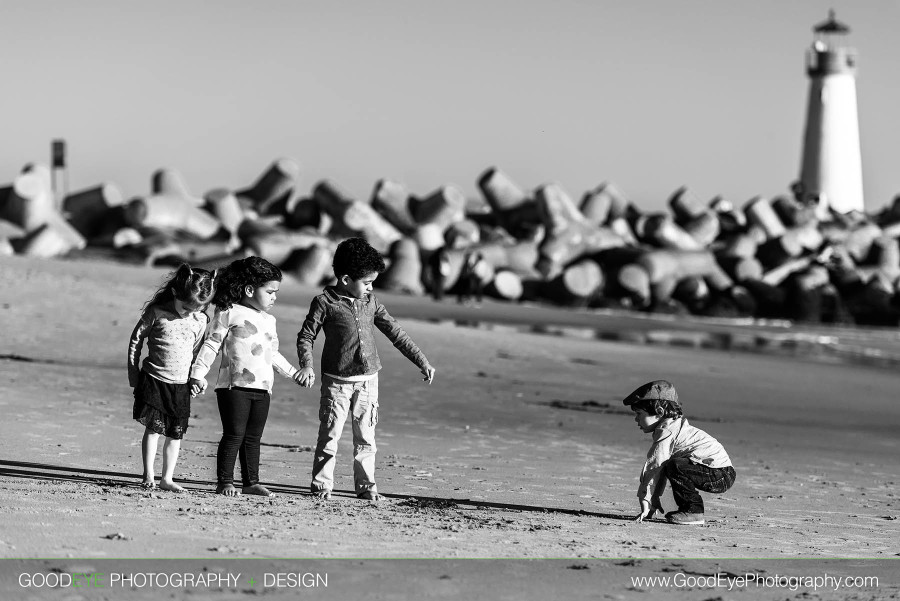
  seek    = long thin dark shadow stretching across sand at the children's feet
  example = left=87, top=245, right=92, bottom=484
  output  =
left=0, top=460, right=632, bottom=521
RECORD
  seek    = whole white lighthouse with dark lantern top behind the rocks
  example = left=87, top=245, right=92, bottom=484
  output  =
left=800, top=11, right=864, bottom=217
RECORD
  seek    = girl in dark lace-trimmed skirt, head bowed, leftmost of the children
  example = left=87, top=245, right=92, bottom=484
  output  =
left=128, top=264, right=215, bottom=492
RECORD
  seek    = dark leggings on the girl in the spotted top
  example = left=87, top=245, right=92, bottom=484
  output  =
left=216, top=387, right=270, bottom=486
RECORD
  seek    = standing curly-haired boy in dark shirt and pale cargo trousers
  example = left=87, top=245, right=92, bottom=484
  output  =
left=297, top=238, right=434, bottom=501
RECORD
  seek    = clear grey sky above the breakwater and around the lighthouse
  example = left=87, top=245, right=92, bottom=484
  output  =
left=0, top=0, right=900, bottom=210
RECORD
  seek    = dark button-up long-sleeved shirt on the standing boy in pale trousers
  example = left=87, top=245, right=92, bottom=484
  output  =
left=297, top=286, right=428, bottom=378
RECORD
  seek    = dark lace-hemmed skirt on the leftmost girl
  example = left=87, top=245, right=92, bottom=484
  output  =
left=132, top=371, right=191, bottom=439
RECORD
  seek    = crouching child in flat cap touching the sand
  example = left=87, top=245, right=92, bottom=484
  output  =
left=622, top=380, right=735, bottom=524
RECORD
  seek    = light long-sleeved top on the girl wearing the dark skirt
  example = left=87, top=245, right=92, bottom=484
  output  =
left=128, top=303, right=209, bottom=388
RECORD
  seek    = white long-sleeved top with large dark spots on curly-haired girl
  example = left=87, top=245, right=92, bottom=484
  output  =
left=191, top=305, right=297, bottom=392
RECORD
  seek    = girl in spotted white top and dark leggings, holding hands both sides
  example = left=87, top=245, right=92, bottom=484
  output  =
left=191, top=257, right=299, bottom=497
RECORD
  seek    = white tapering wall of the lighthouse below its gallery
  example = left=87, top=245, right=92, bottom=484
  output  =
left=800, top=73, right=864, bottom=213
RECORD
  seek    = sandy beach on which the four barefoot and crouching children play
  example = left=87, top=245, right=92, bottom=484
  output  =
left=0, top=257, right=900, bottom=599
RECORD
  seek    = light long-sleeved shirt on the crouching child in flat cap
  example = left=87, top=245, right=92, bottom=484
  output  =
left=637, top=417, right=731, bottom=502
